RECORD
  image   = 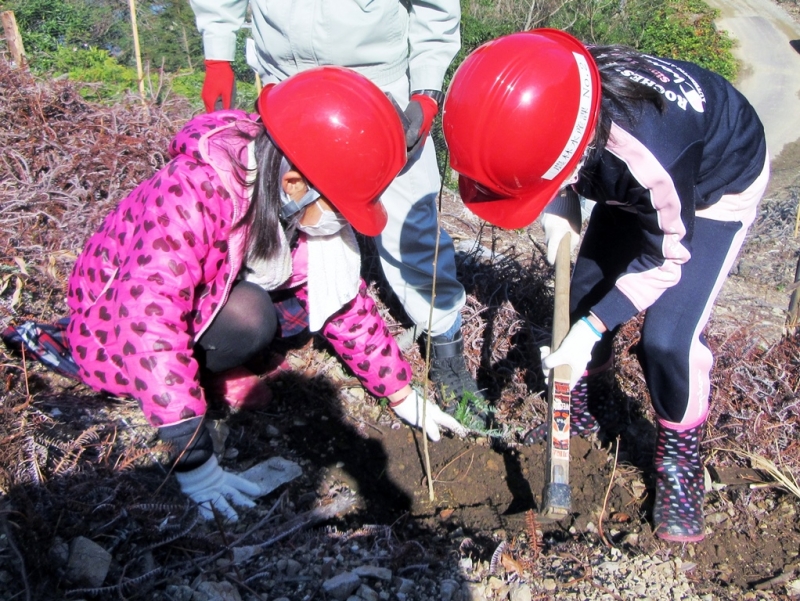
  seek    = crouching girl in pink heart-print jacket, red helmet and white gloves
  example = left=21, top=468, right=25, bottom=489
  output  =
left=67, top=67, right=463, bottom=520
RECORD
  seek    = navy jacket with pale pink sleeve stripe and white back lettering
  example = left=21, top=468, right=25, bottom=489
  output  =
left=574, top=57, right=767, bottom=329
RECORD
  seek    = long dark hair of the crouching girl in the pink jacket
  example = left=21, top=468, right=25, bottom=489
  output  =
left=231, top=127, right=284, bottom=260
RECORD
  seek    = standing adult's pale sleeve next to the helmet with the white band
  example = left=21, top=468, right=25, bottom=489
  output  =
left=408, top=0, right=461, bottom=91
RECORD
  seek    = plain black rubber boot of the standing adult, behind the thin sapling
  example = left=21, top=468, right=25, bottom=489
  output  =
left=428, top=332, right=491, bottom=428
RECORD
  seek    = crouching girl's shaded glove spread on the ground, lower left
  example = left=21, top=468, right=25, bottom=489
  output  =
left=175, top=455, right=261, bottom=522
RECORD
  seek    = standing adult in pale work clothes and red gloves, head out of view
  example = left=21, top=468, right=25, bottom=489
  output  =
left=190, top=0, right=485, bottom=418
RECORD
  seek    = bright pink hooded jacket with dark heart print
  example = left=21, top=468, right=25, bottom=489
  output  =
left=67, top=111, right=412, bottom=426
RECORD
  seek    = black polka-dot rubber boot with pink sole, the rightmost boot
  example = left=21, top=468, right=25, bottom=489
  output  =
left=653, top=423, right=706, bottom=543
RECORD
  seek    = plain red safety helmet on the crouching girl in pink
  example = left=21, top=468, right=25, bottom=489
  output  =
left=257, top=67, right=406, bottom=236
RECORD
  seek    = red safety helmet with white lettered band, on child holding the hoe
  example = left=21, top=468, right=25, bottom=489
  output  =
left=442, top=29, right=600, bottom=229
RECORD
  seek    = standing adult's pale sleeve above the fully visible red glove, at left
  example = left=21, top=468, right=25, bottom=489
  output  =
left=189, top=0, right=249, bottom=61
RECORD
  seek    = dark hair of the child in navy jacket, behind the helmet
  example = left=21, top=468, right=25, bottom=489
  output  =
left=587, top=45, right=665, bottom=161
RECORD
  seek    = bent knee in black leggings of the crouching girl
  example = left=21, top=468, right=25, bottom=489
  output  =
left=194, top=281, right=278, bottom=373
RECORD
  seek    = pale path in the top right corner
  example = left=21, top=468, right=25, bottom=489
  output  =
left=707, top=0, right=800, bottom=158
